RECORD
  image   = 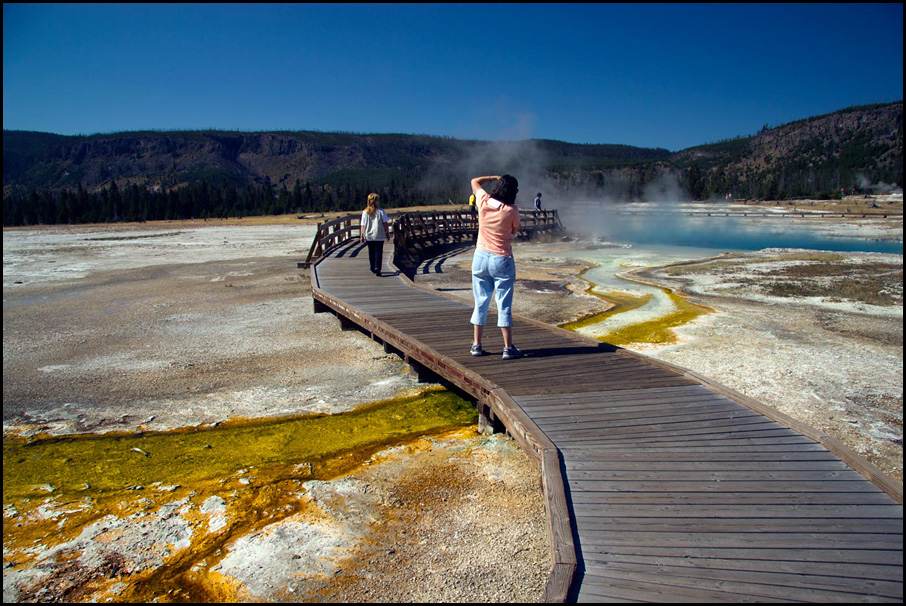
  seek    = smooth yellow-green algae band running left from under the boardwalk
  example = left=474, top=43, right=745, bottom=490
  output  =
left=3, top=389, right=477, bottom=503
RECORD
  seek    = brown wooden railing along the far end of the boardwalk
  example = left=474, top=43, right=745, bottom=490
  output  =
left=298, top=209, right=563, bottom=268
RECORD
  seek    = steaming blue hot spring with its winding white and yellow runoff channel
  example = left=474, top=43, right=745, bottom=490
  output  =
left=561, top=205, right=903, bottom=345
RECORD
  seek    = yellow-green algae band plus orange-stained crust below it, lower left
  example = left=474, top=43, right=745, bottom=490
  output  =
left=3, top=388, right=477, bottom=603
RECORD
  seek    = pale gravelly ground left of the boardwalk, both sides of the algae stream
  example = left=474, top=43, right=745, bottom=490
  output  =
left=3, top=223, right=549, bottom=602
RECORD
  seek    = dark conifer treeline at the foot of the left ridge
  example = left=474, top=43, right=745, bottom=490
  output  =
left=3, top=180, right=434, bottom=227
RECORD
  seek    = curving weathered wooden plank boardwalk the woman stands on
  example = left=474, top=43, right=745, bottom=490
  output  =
left=312, top=224, right=903, bottom=602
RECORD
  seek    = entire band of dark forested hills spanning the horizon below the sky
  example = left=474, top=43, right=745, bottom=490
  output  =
left=3, top=101, right=903, bottom=225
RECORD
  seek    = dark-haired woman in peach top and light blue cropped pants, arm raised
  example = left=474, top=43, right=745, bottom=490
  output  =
left=470, top=175, right=522, bottom=360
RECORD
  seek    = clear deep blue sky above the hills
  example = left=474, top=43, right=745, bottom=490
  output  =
left=3, top=4, right=903, bottom=151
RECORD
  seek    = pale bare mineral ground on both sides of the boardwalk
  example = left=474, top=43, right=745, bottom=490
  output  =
left=3, top=210, right=902, bottom=601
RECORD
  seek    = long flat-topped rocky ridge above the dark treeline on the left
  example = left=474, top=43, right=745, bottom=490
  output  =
left=3, top=131, right=669, bottom=193
